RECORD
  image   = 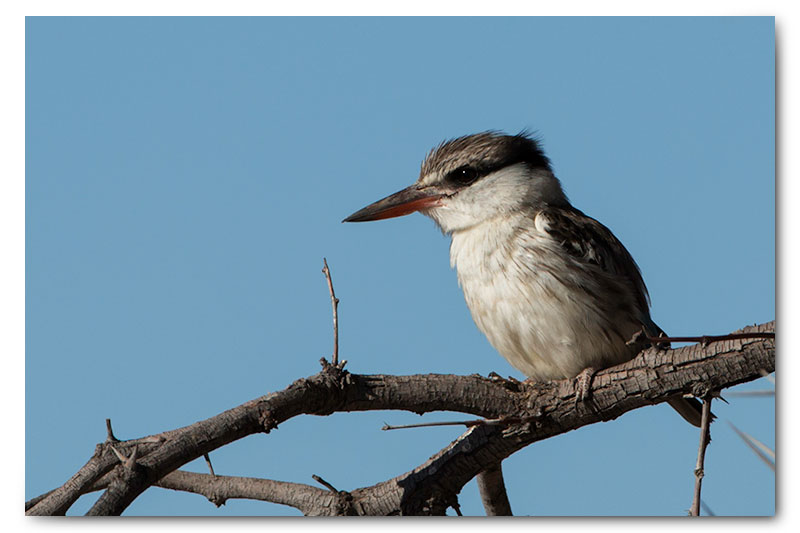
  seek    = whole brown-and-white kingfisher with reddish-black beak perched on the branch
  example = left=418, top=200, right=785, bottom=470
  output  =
left=343, top=130, right=701, bottom=427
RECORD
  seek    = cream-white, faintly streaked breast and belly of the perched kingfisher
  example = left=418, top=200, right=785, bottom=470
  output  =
left=450, top=217, right=637, bottom=380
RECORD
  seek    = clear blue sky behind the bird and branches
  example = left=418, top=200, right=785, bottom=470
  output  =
left=25, top=17, right=775, bottom=515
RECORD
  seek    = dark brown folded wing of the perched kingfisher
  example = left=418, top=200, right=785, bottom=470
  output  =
left=536, top=207, right=658, bottom=312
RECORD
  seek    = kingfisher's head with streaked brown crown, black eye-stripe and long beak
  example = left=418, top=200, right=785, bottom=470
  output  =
left=344, top=131, right=568, bottom=233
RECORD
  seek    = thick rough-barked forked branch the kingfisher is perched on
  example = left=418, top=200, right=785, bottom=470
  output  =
left=29, top=322, right=775, bottom=515
